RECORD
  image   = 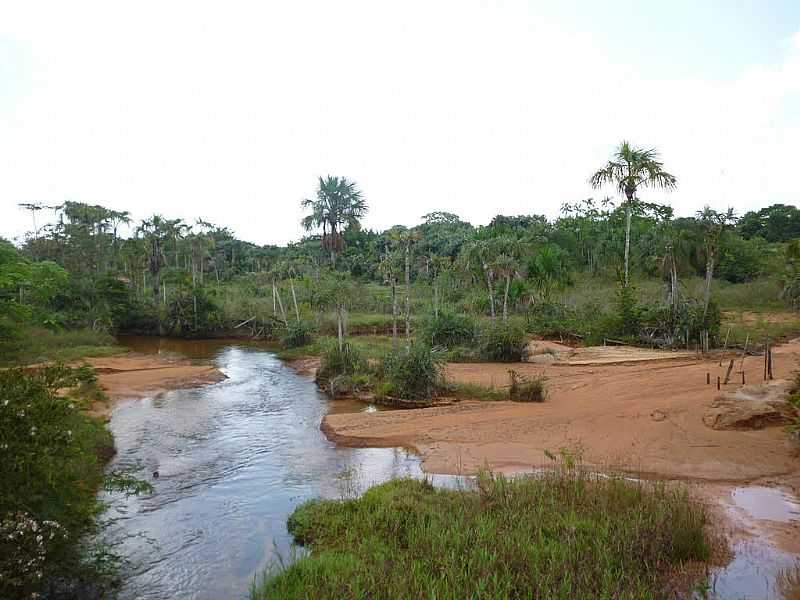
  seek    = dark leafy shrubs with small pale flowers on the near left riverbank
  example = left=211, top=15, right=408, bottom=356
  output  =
left=0, top=367, right=150, bottom=598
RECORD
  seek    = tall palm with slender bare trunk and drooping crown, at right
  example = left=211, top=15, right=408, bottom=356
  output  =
left=589, top=141, right=678, bottom=287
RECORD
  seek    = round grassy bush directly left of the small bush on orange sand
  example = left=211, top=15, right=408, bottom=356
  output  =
left=383, top=344, right=444, bottom=400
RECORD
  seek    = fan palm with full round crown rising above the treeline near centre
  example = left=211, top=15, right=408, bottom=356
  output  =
left=301, top=175, right=367, bottom=266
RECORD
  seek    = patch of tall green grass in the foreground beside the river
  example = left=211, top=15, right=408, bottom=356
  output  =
left=250, top=467, right=710, bottom=600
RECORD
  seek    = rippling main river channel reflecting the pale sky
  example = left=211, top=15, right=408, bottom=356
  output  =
left=103, top=338, right=446, bottom=599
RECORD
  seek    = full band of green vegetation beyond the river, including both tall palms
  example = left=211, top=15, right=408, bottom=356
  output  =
left=7, top=165, right=800, bottom=363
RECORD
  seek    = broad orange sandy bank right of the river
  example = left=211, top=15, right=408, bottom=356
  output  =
left=322, top=343, right=800, bottom=482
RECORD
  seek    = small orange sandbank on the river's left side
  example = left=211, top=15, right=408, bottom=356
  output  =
left=85, top=353, right=225, bottom=417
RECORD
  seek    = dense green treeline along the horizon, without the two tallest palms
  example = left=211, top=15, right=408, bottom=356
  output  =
left=0, top=199, right=800, bottom=341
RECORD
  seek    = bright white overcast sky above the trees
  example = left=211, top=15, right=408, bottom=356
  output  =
left=0, top=0, right=800, bottom=244
